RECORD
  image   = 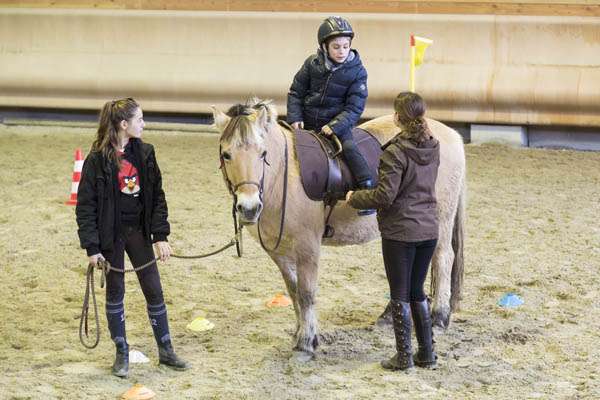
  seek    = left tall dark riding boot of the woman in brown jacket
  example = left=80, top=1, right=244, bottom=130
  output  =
left=381, top=299, right=414, bottom=370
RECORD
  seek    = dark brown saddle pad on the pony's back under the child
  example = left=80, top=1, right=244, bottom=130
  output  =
left=295, top=128, right=382, bottom=201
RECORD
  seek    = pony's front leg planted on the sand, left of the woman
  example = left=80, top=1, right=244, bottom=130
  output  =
left=294, top=256, right=319, bottom=361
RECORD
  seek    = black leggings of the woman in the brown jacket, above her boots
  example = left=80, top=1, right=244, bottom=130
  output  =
left=381, top=239, right=437, bottom=303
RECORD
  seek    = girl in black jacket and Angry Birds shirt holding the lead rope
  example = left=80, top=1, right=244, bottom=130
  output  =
left=75, top=98, right=189, bottom=378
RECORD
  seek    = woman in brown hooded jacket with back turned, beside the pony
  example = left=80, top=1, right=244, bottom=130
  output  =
left=346, top=92, right=440, bottom=370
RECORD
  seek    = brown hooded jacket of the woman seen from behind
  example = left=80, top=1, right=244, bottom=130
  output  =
left=349, top=135, right=440, bottom=242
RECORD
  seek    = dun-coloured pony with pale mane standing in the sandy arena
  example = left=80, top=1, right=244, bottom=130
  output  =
left=214, top=99, right=465, bottom=359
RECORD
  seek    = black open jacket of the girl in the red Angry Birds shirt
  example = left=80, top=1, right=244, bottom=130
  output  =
left=75, top=139, right=170, bottom=255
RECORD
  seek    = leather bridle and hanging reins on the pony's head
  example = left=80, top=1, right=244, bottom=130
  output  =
left=219, top=121, right=288, bottom=252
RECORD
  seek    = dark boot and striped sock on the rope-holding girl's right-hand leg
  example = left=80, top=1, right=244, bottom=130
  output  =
left=148, top=302, right=190, bottom=371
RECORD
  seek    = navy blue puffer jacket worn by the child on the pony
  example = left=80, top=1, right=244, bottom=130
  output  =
left=287, top=50, right=368, bottom=141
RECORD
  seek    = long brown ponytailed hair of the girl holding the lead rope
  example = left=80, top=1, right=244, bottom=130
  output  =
left=92, top=97, right=140, bottom=165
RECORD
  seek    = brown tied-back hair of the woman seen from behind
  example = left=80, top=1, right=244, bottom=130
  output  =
left=394, top=92, right=431, bottom=145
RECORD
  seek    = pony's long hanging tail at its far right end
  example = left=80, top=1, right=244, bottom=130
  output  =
left=450, top=178, right=467, bottom=312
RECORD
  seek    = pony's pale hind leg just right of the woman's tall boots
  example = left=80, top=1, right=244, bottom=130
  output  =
left=431, top=233, right=454, bottom=330
